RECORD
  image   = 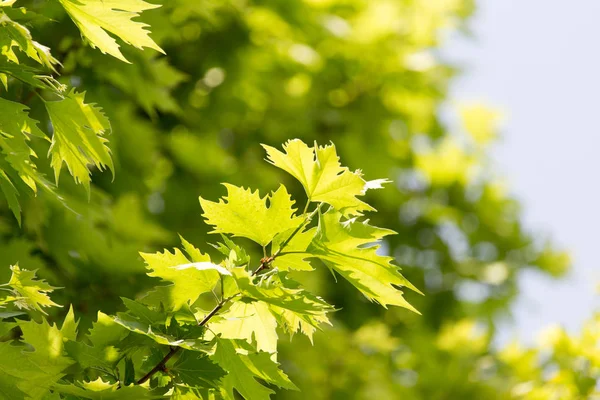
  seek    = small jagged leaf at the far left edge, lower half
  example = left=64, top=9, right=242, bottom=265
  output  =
left=8, top=265, right=59, bottom=314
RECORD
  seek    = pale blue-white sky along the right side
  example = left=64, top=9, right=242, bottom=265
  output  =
left=444, top=0, right=600, bottom=342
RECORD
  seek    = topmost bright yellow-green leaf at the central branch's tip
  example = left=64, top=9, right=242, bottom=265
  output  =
left=262, top=139, right=373, bottom=215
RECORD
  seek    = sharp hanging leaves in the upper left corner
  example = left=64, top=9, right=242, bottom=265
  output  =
left=0, top=0, right=162, bottom=223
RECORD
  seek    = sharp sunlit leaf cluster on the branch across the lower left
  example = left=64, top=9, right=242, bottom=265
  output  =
left=0, top=140, right=414, bottom=400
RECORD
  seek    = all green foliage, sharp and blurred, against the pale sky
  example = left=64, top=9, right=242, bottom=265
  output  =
left=0, top=0, right=598, bottom=400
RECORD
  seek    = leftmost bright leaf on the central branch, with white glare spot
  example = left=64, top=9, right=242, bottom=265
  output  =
left=141, top=239, right=230, bottom=311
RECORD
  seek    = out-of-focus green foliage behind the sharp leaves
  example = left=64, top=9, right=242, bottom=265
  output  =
left=0, top=0, right=600, bottom=400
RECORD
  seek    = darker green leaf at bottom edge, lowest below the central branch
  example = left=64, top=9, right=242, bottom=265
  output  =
left=212, top=339, right=296, bottom=400
